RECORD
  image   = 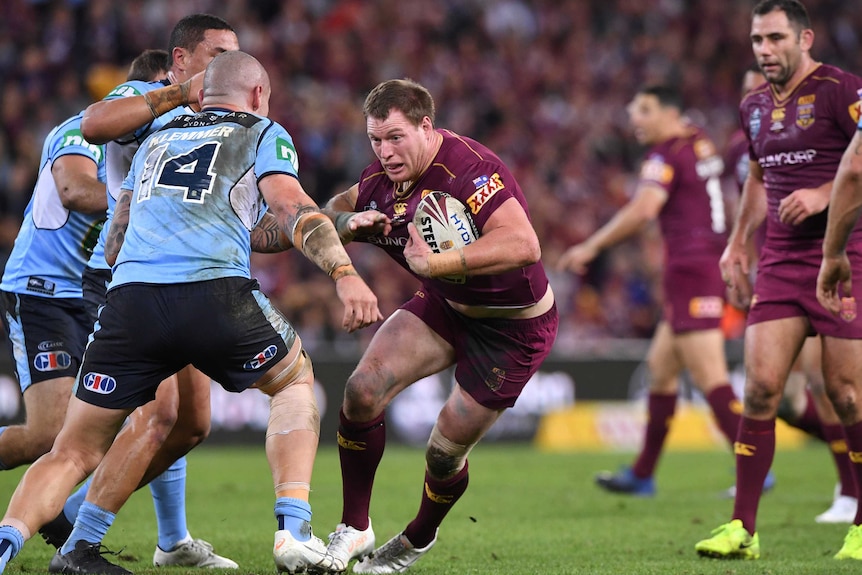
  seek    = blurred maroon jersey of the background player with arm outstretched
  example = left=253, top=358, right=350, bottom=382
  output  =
left=640, top=128, right=727, bottom=266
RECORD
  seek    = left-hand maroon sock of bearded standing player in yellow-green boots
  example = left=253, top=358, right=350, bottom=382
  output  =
left=733, top=416, right=775, bottom=534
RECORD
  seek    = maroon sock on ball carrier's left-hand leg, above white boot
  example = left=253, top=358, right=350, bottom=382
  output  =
left=338, top=411, right=386, bottom=530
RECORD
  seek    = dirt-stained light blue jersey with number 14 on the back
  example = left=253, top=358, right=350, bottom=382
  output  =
left=111, top=109, right=298, bottom=287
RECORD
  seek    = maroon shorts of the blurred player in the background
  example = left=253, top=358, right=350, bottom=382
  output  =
left=662, top=258, right=726, bottom=334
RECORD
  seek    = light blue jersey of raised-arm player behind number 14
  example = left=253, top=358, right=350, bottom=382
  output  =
left=87, top=80, right=192, bottom=269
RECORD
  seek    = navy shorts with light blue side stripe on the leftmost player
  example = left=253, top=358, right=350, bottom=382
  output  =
left=0, top=291, right=93, bottom=393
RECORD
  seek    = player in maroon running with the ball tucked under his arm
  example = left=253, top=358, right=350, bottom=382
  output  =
left=324, top=80, right=558, bottom=573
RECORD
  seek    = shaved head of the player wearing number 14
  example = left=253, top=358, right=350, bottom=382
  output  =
left=201, top=50, right=270, bottom=116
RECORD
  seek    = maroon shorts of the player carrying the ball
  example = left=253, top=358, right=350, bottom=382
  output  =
left=401, top=291, right=559, bottom=409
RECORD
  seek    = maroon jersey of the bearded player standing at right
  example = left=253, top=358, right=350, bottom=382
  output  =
left=739, top=64, right=862, bottom=251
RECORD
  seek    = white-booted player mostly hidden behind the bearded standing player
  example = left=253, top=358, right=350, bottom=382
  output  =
left=727, top=64, right=857, bottom=523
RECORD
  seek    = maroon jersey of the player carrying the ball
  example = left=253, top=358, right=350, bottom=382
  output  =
left=356, top=130, right=548, bottom=307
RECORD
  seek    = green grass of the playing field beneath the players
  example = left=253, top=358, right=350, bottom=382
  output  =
left=0, top=444, right=862, bottom=575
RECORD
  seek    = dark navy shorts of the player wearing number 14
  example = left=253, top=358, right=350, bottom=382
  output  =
left=75, top=277, right=296, bottom=409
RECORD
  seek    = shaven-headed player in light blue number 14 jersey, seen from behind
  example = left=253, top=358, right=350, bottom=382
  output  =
left=0, top=51, right=382, bottom=573
